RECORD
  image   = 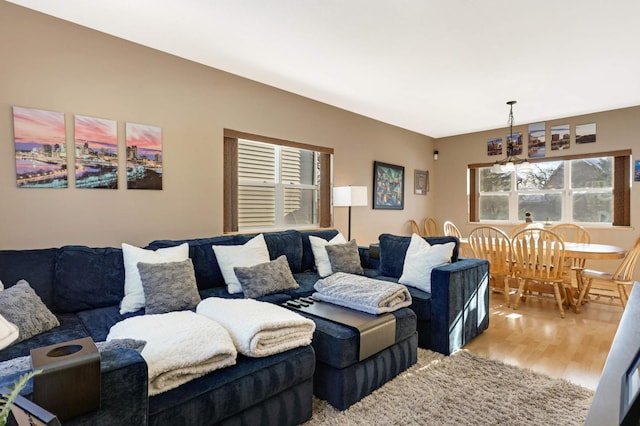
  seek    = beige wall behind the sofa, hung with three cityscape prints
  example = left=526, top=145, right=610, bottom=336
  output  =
left=0, top=1, right=434, bottom=249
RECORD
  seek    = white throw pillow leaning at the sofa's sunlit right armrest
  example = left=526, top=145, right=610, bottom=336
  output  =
left=398, top=234, right=456, bottom=293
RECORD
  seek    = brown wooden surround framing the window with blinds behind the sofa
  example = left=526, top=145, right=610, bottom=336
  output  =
left=223, top=129, right=333, bottom=233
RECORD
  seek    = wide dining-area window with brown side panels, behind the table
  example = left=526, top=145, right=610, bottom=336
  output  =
left=470, top=152, right=630, bottom=225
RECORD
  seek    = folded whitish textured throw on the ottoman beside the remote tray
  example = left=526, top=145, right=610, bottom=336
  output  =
left=313, top=272, right=411, bottom=315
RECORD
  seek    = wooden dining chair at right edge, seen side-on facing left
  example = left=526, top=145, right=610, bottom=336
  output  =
left=576, top=238, right=640, bottom=312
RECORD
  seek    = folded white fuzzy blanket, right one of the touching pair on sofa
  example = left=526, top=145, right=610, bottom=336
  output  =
left=196, top=297, right=316, bottom=357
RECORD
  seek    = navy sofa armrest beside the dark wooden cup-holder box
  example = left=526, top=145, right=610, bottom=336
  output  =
left=64, top=349, right=149, bottom=426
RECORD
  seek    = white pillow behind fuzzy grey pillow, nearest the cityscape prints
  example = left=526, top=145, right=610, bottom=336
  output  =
left=120, top=243, right=189, bottom=314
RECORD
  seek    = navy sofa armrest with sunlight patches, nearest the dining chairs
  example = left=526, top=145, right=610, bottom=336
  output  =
left=431, top=259, right=489, bottom=355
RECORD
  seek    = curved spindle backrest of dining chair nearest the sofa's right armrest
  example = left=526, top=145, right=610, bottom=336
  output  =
left=469, top=226, right=511, bottom=274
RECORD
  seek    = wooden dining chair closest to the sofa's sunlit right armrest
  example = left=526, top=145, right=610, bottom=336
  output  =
left=469, top=226, right=511, bottom=306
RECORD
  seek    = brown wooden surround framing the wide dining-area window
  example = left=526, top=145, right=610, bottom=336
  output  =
left=467, top=149, right=632, bottom=227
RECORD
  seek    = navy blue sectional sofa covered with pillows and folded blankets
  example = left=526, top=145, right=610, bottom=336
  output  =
left=0, top=230, right=488, bottom=425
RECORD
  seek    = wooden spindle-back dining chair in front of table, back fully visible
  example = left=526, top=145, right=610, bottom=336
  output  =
left=511, top=228, right=568, bottom=318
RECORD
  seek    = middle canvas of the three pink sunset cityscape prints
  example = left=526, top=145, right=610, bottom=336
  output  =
left=74, top=115, right=118, bottom=189
